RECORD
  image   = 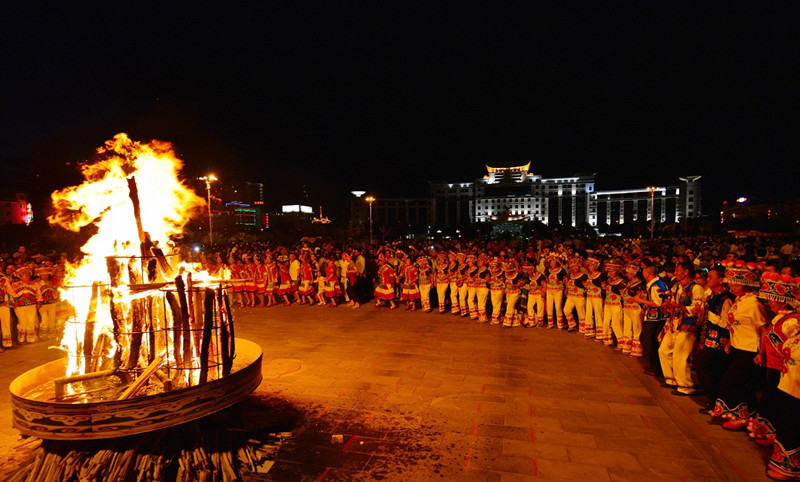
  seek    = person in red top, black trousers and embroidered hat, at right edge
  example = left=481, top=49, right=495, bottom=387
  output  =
left=747, top=273, right=800, bottom=446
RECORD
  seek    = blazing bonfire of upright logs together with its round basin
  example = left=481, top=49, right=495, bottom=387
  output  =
left=10, top=134, right=262, bottom=440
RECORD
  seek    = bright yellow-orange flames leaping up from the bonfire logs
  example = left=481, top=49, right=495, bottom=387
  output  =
left=48, top=133, right=205, bottom=375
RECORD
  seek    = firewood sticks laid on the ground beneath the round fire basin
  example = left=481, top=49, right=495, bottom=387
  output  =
left=8, top=411, right=291, bottom=482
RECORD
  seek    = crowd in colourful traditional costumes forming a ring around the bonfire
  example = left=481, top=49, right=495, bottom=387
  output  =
left=0, top=238, right=800, bottom=480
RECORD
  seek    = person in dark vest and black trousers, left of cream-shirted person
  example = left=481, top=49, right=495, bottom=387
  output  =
left=692, top=266, right=736, bottom=414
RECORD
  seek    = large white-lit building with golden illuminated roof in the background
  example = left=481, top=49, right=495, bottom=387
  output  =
left=430, top=163, right=701, bottom=227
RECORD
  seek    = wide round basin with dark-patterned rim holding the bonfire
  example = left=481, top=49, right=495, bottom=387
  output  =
left=9, top=338, right=262, bottom=440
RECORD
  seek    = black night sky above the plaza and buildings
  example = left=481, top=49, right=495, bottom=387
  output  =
left=0, top=1, right=800, bottom=217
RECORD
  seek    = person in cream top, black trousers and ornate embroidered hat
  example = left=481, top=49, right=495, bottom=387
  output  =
left=711, top=260, right=769, bottom=430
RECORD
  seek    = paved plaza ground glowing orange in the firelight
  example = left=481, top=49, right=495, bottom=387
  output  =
left=0, top=305, right=769, bottom=482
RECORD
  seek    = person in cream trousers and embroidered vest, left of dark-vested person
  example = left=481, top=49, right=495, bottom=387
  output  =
left=658, top=261, right=706, bottom=395
